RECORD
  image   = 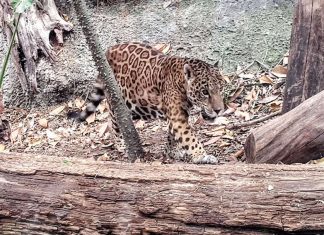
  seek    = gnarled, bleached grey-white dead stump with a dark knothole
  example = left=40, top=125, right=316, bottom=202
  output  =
left=0, top=0, right=73, bottom=92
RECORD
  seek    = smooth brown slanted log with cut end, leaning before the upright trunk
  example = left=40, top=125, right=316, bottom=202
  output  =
left=244, top=91, right=324, bottom=164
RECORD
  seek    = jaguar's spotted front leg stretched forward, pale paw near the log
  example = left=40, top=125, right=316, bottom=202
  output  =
left=168, top=110, right=218, bottom=164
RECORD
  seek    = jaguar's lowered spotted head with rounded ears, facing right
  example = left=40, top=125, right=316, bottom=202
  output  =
left=184, top=59, right=225, bottom=121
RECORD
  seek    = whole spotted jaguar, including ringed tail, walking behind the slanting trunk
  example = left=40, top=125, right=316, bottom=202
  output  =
left=69, top=43, right=224, bottom=163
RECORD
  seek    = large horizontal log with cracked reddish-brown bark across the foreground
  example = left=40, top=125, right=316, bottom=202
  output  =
left=0, top=153, right=324, bottom=234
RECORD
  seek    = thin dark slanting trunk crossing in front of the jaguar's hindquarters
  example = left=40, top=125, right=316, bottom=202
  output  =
left=73, top=0, right=144, bottom=161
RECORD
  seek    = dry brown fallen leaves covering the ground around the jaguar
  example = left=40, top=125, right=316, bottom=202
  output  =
left=0, top=51, right=314, bottom=163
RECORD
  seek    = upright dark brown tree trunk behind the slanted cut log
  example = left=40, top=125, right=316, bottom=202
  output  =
left=283, top=0, right=324, bottom=112
